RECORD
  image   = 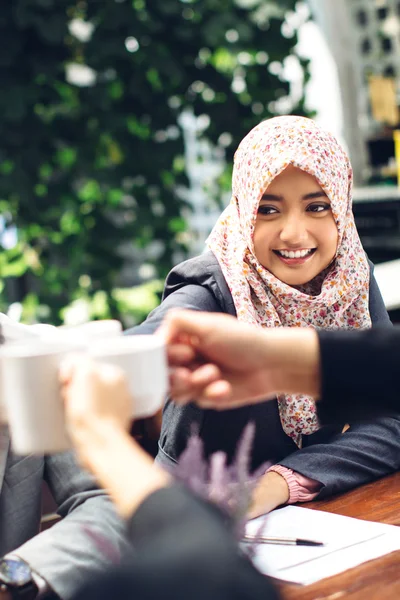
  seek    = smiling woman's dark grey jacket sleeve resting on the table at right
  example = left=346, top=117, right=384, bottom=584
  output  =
left=279, top=415, right=400, bottom=499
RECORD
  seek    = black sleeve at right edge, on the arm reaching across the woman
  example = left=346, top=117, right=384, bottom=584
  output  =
left=317, top=327, right=400, bottom=423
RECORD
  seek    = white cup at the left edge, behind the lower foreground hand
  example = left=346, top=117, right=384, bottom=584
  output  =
left=0, top=340, right=83, bottom=454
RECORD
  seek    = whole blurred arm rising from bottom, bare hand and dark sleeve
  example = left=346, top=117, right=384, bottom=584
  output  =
left=61, top=358, right=278, bottom=600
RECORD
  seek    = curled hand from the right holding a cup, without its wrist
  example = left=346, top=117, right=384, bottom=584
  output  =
left=160, top=311, right=282, bottom=409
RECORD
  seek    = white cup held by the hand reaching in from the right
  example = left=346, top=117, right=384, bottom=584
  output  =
left=89, top=335, right=168, bottom=419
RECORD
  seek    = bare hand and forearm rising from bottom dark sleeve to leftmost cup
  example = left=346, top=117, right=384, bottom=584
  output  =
left=59, top=356, right=170, bottom=520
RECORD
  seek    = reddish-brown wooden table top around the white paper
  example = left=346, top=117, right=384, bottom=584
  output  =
left=278, top=473, right=400, bottom=600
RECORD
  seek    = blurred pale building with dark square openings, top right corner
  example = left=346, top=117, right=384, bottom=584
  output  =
left=309, top=0, right=400, bottom=185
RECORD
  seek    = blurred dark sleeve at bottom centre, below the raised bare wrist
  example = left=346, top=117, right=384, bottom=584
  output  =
left=72, top=486, right=279, bottom=600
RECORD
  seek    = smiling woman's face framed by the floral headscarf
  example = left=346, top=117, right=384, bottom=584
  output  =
left=254, top=165, right=338, bottom=286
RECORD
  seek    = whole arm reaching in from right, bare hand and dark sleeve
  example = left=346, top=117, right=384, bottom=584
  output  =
left=159, top=310, right=400, bottom=423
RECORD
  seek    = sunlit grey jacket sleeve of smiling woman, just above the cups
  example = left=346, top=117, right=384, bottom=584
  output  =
left=125, top=284, right=222, bottom=335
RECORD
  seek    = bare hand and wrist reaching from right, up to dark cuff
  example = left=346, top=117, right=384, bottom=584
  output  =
left=159, top=310, right=319, bottom=410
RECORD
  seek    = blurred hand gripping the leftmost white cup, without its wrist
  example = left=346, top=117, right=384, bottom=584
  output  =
left=60, top=356, right=133, bottom=469
